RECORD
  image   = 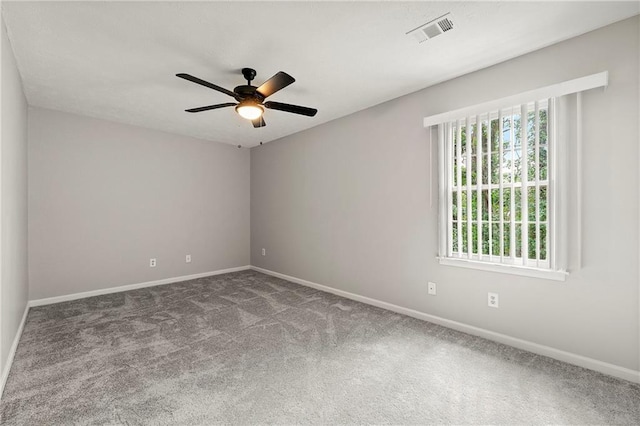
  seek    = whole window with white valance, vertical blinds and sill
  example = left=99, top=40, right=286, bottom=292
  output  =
left=424, top=71, right=608, bottom=281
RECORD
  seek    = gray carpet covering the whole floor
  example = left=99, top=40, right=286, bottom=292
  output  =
left=0, top=271, right=640, bottom=425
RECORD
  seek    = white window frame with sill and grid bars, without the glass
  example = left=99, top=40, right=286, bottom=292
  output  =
left=438, top=98, right=566, bottom=281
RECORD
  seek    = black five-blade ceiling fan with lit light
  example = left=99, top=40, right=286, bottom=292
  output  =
left=176, top=68, right=318, bottom=128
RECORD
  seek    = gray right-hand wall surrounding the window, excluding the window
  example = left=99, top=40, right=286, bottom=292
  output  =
left=251, top=17, right=640, bottom=370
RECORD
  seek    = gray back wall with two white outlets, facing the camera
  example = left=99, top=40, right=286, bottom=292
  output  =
left=29, top=108, right=250, bottom=299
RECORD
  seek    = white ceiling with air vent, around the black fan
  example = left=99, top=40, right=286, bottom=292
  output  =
left=2, top=1, right=640, bottom=146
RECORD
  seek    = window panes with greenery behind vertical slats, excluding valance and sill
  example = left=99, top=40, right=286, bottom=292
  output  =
left=444, top=99, right=553, bottom=269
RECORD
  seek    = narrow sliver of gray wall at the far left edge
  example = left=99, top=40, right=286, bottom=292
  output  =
left=0, top=19, right=27, bottom=376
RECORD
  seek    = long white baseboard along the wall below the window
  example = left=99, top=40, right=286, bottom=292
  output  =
left=251, top=266, right=640, bottom=383
